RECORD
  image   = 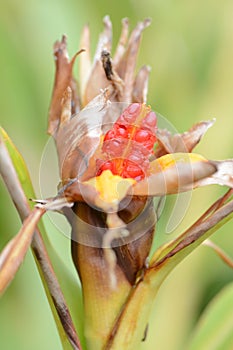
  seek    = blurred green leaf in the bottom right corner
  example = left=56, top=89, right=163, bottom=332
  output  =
left=186, top=283, right=233, bottom=350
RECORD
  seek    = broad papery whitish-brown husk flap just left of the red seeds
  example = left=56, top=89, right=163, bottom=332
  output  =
left=56, top=88, right=108, bottom=183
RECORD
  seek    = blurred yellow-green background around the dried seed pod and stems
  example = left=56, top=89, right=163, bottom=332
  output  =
left=0, top=0, right=233, bottom=350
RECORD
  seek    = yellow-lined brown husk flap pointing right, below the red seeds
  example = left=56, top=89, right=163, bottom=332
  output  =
left=133, top=153, right=233, bottom=196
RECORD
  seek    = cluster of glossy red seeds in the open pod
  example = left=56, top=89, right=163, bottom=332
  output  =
left=96, top=103, right=157, bottom=181
